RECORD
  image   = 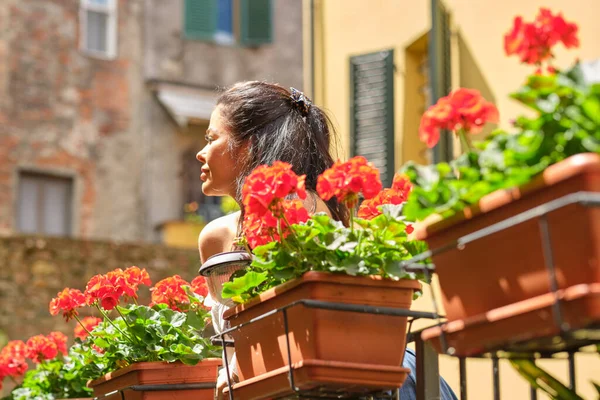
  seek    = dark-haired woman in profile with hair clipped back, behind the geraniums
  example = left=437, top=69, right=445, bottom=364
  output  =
left=196, top=81, right=454, bottom=399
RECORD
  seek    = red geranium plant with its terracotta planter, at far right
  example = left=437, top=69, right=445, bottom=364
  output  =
left=396, top=9, right=600, bottom=355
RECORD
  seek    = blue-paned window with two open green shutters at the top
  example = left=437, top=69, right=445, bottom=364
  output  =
left=184, top=0, right=273, bottom=46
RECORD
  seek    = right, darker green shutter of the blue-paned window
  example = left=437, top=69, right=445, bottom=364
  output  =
left=240, top=0, right=273, bottom=46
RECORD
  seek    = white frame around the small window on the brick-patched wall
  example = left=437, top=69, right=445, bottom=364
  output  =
left=79, top=0, right=118, bottom=60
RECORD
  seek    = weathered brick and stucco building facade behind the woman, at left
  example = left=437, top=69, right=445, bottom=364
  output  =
left=0, top=0, right=303, bottom=243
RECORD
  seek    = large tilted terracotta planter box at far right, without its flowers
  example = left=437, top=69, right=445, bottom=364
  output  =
left=417, top=153, right=600, bottom=323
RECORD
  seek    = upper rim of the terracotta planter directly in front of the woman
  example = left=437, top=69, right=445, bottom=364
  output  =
left=223, top=271, right=422, bottom=320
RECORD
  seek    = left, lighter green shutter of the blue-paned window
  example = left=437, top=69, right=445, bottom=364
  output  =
left=184, top=0, right=217, bottom=40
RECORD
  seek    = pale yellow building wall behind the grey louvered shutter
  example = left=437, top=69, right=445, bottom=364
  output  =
left=305, top=0, right=600, bottom=399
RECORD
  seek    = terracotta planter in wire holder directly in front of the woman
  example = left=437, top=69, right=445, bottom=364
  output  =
left=225, top=271, right=421, bottom=398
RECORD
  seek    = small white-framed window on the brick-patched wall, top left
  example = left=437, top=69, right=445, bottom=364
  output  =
left=79, top=0, right=117, bottom=59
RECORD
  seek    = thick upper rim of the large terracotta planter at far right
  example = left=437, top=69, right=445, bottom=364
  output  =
left=415, top=153, right=600, bottom=240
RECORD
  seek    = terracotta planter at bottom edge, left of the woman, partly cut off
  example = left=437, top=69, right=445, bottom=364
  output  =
left=88, top=358, right=221, bottom=400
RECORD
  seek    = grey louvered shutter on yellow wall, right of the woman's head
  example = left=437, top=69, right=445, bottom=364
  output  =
left=350, top=50, right=395, bottom=186
